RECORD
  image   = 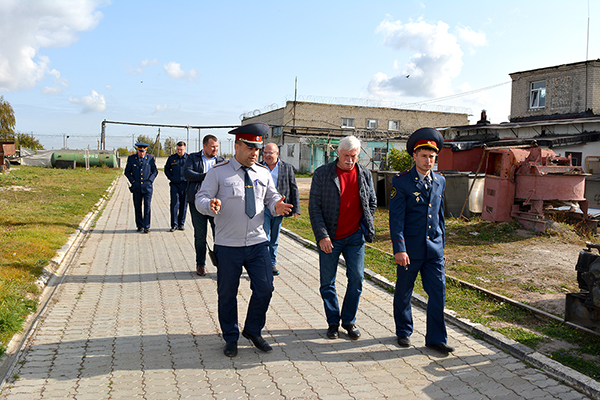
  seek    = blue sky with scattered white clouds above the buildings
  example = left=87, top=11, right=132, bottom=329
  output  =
left=0, top=0, right=600, bottom=152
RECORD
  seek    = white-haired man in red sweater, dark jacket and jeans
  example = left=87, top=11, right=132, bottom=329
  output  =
left=308, top=136, right=377, bottom=340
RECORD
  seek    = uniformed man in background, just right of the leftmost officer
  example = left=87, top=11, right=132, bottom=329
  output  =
left=165, top=142, right=188, bottom=232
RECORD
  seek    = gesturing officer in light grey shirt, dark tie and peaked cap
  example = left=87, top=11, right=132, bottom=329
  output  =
left=195, top=123, right=292, bottom=357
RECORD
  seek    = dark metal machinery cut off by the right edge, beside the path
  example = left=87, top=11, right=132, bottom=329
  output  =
left=565, top=242, right=600, bottom=332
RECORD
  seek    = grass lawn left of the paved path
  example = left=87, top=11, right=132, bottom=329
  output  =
left=0, top=166, right=122, bottom=354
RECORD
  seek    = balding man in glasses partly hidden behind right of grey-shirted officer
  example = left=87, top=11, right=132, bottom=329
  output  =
left=262, top=143, right=300, bottom=275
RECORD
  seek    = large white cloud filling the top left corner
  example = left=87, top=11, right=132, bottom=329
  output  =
left=0, top=0, right=102, bottom=91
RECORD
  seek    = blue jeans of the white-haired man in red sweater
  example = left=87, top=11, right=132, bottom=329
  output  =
left=319, top=229, right=365, bottom=325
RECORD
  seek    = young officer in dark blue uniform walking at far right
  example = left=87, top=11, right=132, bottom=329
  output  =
left=389, top=128, right=454, bottom=354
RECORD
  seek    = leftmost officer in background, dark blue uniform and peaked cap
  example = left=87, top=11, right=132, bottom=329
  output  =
left=125, top=142, right=158, bottom=233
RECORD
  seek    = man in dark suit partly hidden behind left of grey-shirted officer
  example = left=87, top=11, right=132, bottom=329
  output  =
left=183, top=135, right=225, bottom=276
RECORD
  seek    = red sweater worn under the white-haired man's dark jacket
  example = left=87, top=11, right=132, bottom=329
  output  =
left=334, top=166, right=363, bottom=240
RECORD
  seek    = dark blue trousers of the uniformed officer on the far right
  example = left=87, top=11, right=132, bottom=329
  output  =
left=394, top=257, right=448, bottom=344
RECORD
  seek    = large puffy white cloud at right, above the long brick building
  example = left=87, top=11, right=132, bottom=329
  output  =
left=368, top=18, right=485, bottom=98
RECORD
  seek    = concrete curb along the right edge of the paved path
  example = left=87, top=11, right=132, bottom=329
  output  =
left=281, top=227, right=600, bottom=400
